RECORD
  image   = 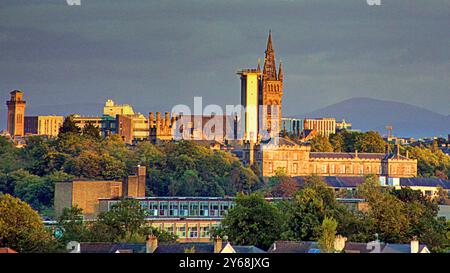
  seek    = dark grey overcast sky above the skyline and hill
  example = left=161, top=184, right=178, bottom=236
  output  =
left=0, top=0, right=450, bottom=115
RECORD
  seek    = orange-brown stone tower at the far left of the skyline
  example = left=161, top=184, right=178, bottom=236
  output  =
left=6, top=90, right=26, bottom=137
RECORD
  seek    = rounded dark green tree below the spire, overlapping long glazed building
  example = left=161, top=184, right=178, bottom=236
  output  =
left=222, top=194, right=282, bottom=249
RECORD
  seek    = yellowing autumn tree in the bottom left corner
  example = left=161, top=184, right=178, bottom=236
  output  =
left=0, top=193, right=56, bottom=252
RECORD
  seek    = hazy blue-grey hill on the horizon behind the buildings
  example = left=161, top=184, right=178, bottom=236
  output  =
left=295, top=98, right=450, bottom=138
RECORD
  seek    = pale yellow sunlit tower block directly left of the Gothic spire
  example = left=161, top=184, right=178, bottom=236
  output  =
left=237, top=69, right=261, bottom=142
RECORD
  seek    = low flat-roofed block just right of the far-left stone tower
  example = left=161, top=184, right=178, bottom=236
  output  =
left=25, top=116, right=64, bottom=137
